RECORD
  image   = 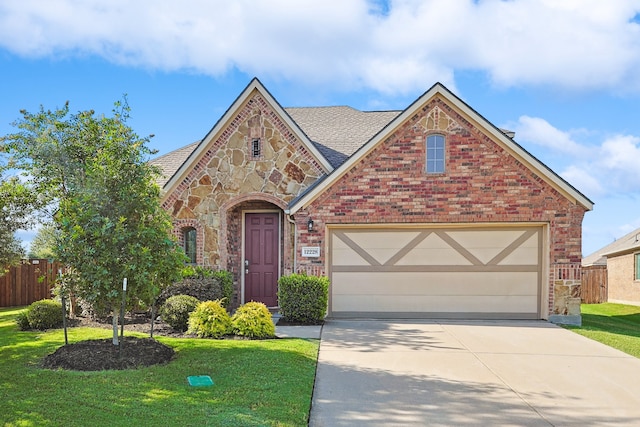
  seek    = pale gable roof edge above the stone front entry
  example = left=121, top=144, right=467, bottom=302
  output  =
left=156, top=77, right=333, bottom=199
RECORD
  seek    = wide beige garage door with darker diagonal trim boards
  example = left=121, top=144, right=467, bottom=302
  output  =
left=329, top=226, right=542, bottom=319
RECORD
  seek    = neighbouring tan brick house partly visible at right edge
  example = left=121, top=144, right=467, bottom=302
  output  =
left=582, top=228, right=640, bottom=305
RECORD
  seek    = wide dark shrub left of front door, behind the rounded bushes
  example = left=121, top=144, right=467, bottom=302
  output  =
left=156, top=267, right=233, bottom=307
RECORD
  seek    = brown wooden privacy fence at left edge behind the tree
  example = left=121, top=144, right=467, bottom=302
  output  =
left=0, top=259, right=61, bottom=307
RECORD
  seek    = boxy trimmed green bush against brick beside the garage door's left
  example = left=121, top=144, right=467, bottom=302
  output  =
left=278, top=274, right=329, bottom=325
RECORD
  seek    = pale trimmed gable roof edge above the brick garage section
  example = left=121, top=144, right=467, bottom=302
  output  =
left=289, top=83, right=593, bottom=214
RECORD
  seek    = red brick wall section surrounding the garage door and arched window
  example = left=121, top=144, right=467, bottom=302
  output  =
left=296, top=98, right=585, bottom=314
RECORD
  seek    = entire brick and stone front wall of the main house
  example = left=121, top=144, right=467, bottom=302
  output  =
left=163, top=81, right=588, bottom=316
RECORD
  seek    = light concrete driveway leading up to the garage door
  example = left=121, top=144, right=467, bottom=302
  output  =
left=309, top=320, right=640, bottom=427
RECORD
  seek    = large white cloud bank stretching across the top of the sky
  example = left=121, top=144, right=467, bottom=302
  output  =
left=0, top=0, right=640, bottom=93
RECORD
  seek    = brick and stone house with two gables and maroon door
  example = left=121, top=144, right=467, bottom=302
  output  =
left=153, top=79, right=593, bottom=322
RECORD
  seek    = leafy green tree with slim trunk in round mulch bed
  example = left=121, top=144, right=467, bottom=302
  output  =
left=3, top=98, right=184, bottom=344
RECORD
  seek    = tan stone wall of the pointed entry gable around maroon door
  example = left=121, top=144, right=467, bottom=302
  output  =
left=163, top=92, right=324, bottom=302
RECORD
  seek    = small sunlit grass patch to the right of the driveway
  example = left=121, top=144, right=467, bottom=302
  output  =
left=568, top=303, right=640, bottom=358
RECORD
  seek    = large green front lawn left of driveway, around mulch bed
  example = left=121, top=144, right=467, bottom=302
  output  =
left=0, top=308, right=319, bottom=427
